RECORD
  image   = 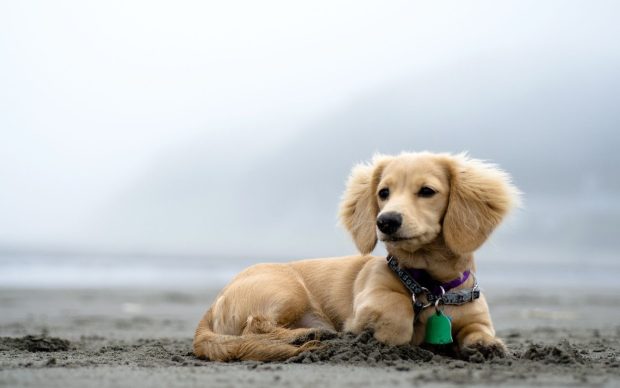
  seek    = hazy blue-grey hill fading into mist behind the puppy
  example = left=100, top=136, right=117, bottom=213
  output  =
left=92, top=58, right=620, bottom=256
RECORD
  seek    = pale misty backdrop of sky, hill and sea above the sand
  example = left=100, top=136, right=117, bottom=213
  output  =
left=0, top=1, right=620, bottom=287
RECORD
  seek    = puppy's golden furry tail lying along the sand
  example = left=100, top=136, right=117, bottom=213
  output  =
left=193, top=309, right=318, bottom=361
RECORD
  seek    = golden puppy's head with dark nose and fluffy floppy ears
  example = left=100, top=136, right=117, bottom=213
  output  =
left=340, top=152, right=518, bottom=256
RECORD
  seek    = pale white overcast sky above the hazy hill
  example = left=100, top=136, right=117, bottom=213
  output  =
left=0, top=0, right=620, bottom=255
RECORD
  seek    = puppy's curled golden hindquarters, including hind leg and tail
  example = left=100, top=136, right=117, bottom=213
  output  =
left=194, top=264, right=334, bottom=361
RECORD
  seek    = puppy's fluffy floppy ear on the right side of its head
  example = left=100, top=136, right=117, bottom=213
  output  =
left=443, top=154, right=520, bottom=255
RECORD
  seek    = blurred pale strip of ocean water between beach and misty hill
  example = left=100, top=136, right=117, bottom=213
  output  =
left=0, top=247, right=620, bottom=289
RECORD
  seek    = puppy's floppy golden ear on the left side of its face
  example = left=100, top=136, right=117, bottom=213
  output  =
left=340, top=155, right=390, bottom=254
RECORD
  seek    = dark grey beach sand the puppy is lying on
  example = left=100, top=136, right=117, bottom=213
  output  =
left=0, top=289, right=620, bottom=387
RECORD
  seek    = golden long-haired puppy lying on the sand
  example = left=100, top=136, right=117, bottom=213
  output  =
left=193, top=152, right=518, bottom=361
